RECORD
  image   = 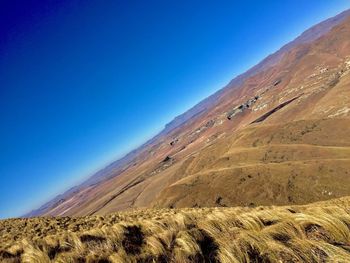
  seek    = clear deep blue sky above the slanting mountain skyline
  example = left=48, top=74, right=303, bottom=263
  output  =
left=0, top=0, right=350, bottom=218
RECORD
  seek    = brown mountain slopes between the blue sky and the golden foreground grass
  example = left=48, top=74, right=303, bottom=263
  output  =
left=25, top=10, right=350, bottom=217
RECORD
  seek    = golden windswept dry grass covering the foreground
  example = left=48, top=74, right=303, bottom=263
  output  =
left=0, top=198, right=350, bottom=263
